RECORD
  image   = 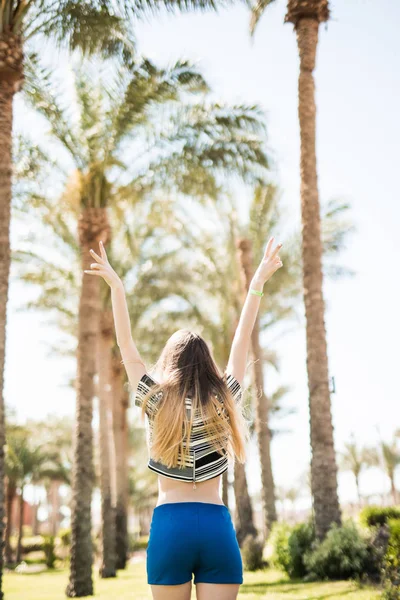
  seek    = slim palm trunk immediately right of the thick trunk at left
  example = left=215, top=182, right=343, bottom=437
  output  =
left=98, top=308, right=117, bottom=578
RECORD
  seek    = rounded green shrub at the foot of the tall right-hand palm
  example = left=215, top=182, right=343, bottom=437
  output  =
left=304, top=522, right=368, bottom=580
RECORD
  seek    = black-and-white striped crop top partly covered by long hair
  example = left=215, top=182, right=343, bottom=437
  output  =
left=135, top=373, right=242, bottom=488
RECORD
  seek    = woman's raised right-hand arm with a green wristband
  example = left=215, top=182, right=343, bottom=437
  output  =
left=226, top=237, right=283, bottom=385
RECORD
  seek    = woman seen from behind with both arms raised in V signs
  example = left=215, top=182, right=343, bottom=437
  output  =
left=85, top=237, right=282, bottom=600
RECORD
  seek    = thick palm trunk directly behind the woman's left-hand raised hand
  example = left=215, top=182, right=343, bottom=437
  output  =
left=66, top=208, right=108, bottom=598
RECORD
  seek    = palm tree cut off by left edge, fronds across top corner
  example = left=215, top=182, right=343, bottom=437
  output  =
left=0, top=5, right=131, bottom=599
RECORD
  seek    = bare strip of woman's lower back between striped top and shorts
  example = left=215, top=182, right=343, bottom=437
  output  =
left=156, top=475, right=223, bottom=506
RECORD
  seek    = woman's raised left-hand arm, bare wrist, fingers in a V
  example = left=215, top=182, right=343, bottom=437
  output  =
left=85, top=242, right=146, bottom=390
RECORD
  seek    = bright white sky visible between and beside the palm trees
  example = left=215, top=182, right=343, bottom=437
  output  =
left=5, top=0, right=400, bottom=508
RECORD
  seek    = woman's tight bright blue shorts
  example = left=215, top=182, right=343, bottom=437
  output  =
left=146, top=502, right=243, bottom=585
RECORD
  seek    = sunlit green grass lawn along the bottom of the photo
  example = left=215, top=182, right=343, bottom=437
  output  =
left=4, top=561, right=380, bottom=600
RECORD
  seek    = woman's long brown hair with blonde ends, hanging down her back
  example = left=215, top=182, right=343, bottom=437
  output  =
left=142, top=329, right=249, bottom=468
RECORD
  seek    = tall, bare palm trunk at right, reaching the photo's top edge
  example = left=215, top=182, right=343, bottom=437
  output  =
left=286, top=0, right=341, bottom=539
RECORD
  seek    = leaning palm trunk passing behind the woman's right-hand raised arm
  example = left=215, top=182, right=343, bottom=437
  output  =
left=238, top=239, right=277, bottom=537
